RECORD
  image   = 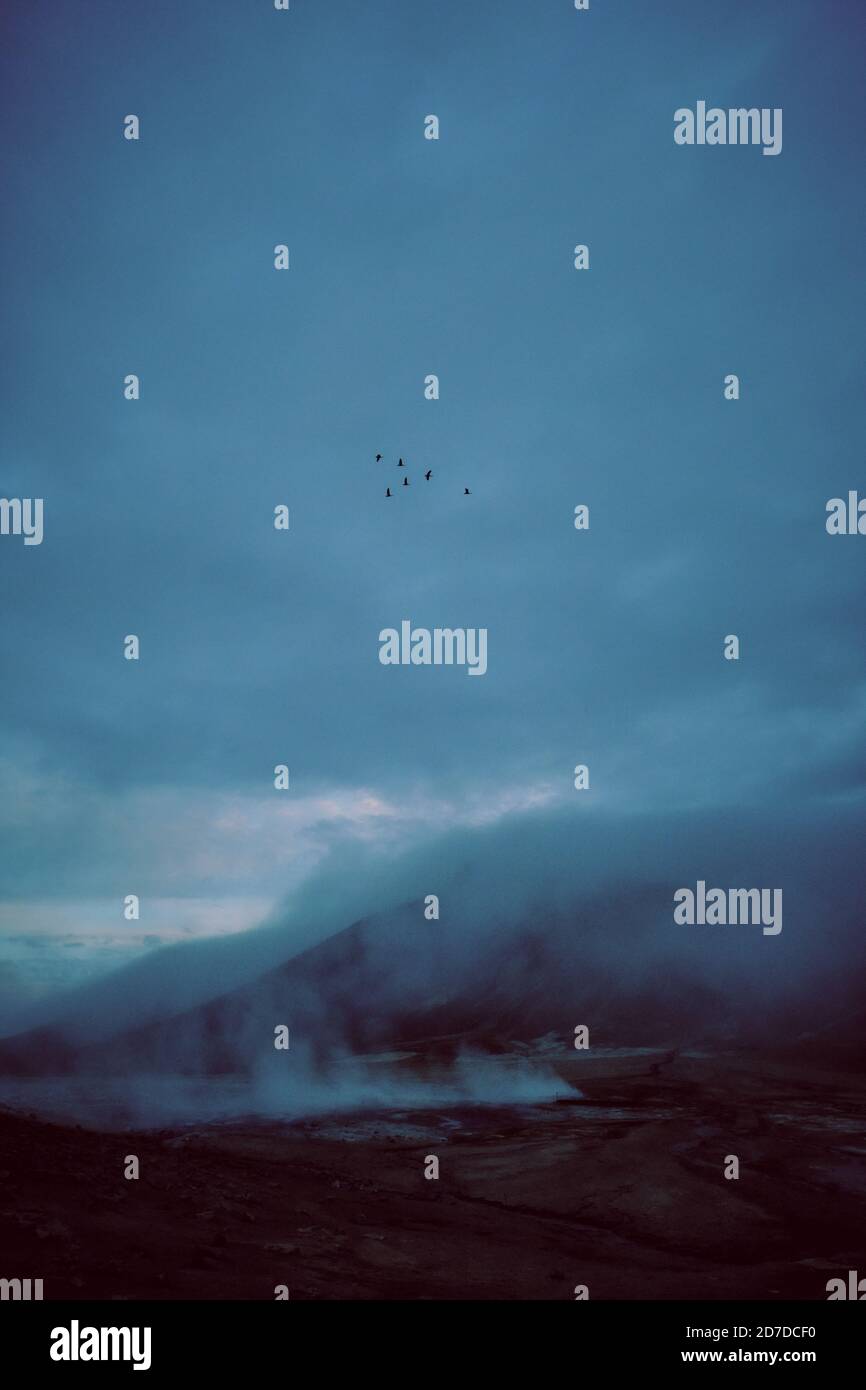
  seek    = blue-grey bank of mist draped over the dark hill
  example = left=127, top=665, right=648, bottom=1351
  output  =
left=0, top=803, right=865, bottom=1112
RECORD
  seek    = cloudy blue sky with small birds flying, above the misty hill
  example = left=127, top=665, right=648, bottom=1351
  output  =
left=0, top=0, right=866, bottom=1016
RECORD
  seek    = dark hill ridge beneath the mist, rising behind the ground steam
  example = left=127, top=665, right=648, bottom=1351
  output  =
left=0, top=890, right=862, bottom=1076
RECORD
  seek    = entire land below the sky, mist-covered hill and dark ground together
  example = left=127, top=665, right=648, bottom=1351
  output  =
left=0, top=816, right=866, bottom=1301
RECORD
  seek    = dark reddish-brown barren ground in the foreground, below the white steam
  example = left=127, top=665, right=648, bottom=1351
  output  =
left=0, top=1049, right=866, bottom=1300
